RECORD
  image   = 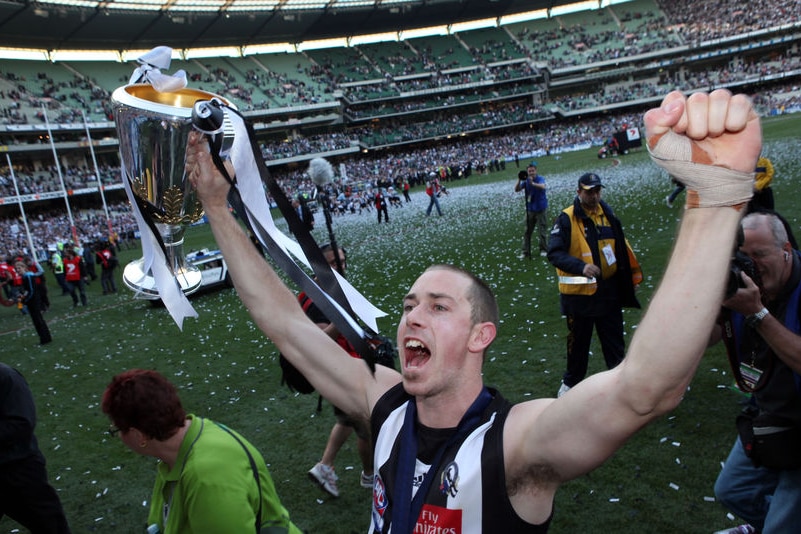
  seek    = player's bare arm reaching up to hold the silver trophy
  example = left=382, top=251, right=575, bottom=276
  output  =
left=186, top=133, right=400, bottom=417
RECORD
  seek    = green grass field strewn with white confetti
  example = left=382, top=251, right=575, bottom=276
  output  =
left=0, top=112, right=801, bottom=534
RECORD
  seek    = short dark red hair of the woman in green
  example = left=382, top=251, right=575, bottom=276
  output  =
left=100, top=369, right=186, bottom=441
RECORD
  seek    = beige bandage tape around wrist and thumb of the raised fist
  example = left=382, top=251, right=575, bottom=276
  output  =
left=648, top=131, right=756, bottom=208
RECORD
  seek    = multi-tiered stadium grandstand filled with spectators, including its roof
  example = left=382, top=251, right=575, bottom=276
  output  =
left=0, top=0, right=801, bottom=260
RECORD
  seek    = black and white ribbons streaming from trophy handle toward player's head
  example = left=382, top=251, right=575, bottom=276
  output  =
left=193, top=99, right=386, bottom=370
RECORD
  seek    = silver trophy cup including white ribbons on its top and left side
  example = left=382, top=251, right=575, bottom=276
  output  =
left=111, top=47, right=231, bottom=327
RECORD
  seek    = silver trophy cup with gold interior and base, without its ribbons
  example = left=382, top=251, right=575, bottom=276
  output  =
left=111, top=84, right=230, bottom=300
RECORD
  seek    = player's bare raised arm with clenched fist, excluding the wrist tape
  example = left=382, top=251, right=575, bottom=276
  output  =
left=505, top=91, right=761, bottom=492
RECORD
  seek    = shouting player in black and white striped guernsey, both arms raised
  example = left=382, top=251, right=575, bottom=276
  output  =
left=187, top=90, right=761, bottom=534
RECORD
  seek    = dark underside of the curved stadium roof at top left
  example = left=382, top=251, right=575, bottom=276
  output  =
left=0, top=0, right=584, bottom=51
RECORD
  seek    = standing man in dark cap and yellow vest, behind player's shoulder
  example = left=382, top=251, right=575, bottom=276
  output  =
left=548, top=173, right=642, bottom=396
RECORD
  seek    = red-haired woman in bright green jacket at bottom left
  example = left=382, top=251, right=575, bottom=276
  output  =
left=101, top=369, right=301, bottom=534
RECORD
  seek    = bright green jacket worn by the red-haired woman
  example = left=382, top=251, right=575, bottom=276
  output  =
left=148, top=414, right=301, bottom=534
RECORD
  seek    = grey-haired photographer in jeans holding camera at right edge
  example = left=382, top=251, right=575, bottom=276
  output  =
left=715, top=213, right=801, bottom=533
